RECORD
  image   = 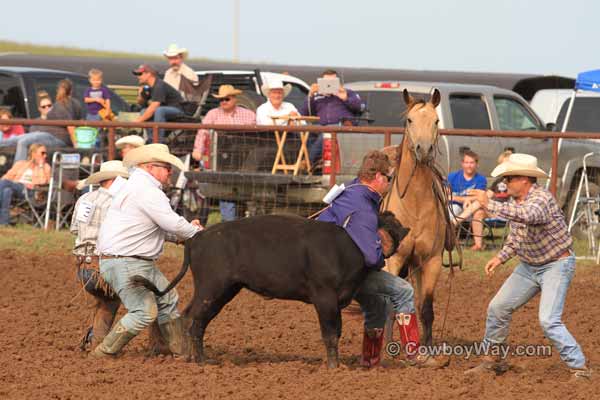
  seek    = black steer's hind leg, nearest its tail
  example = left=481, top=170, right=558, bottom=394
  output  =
left=189, top=285, right=242, bottom=363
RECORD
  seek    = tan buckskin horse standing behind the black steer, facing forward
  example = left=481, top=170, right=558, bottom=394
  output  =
left=382, top=89, right=454, bottom=344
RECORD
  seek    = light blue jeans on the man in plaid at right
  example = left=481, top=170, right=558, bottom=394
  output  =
left=483, top=255, right=585, bottom=368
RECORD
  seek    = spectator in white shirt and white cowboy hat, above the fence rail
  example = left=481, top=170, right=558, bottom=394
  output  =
left=256, top=79, right=300, bottom=125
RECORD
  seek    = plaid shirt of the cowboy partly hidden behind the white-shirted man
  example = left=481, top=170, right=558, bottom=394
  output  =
left=70, top=188, right=112, bottom=256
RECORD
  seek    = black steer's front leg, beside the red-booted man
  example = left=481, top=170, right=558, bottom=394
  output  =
left=314, top=293, right=342, bottom=368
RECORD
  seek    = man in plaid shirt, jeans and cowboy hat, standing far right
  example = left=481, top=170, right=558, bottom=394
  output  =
left=467, top=154, right=591, bottom=379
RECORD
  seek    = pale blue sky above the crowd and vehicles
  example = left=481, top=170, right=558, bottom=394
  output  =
left=0, top=0, right=600, bottom=77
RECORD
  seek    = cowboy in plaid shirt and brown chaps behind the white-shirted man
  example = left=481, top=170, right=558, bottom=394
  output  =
left=70, top=161, right=129, bottom=350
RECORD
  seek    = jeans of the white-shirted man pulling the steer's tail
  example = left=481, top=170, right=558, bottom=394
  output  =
left=100, top=257, right=179, bottom=334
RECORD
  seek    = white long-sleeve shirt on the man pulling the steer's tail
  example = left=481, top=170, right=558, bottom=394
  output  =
left=97, top=168, right=200, bottom=259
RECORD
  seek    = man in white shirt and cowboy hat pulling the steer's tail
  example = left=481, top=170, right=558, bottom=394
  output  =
left=92, top=144, right=203, bottom=356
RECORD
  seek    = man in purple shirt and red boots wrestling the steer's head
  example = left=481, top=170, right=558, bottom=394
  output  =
left=318, top=151, right=443, bottom=368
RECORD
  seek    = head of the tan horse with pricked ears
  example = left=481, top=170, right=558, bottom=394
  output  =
left=403, top=89, right=440, bottom=162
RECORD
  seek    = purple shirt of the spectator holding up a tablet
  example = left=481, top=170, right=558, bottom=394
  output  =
left=300, top=89, right=362, bottom=125
